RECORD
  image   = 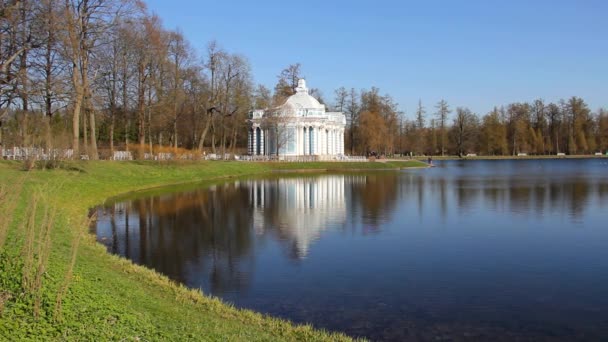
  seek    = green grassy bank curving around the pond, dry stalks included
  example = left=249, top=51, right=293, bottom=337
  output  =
left=0, top=161, right=420, bottom=341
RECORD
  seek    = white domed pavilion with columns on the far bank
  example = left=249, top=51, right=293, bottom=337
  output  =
left=248, top=79, right=346, bottom=159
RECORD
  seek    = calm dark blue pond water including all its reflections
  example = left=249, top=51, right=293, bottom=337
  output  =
left=96, top=159, right=608, bottom=340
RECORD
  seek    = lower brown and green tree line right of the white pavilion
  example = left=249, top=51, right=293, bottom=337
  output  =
left=335, top=88, right=608, bottom=156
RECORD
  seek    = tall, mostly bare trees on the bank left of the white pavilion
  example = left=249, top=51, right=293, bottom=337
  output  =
left=0, top=0, right=254, bottom=159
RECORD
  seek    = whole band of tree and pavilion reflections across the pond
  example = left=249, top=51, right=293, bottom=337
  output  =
left=98, top=172, right=608, bottom=300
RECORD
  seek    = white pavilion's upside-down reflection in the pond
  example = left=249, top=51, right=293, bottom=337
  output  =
left=249, top=175, right=346, bottom=258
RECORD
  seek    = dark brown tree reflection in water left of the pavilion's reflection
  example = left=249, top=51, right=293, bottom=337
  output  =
left=101, top=183, right=252, bottom=293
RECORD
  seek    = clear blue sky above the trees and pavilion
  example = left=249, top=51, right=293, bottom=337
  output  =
left=146, top=0, right=608, bottom=118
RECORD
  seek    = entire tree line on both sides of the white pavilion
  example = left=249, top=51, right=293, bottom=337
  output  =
left=0, top=0, right=608, bottom=159
